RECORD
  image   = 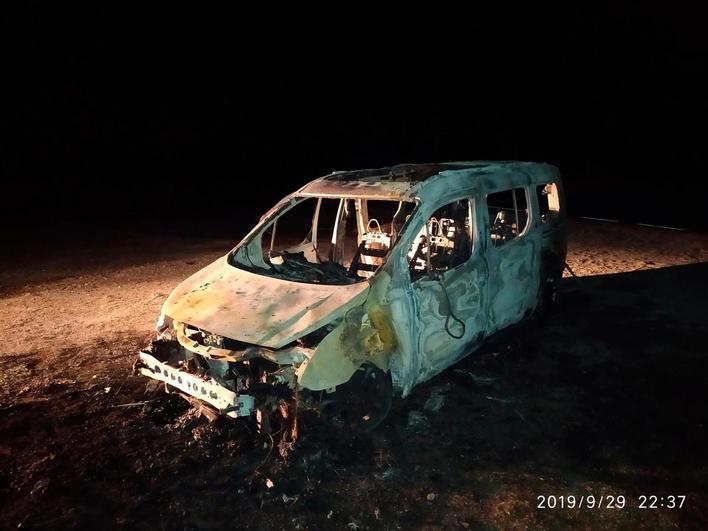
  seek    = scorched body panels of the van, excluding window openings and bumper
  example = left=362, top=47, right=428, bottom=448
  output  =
left=141, top=162, right=565, bottom=418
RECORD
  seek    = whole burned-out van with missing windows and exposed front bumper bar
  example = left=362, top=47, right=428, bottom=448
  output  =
left=138, top=162, right=566, bottom=432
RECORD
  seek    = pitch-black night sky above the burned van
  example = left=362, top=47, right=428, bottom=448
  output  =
left=0, top=4, right=708, bottom=230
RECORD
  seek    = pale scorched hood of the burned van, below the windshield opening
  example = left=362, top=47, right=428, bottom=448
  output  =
left=162, top=256, right=369, bottom=348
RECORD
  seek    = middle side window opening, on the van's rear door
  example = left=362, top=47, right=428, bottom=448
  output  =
left=487, top=188, right=529, bottom=247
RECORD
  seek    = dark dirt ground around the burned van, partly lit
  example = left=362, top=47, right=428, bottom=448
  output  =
left=0, top=221, right=708, bottom=529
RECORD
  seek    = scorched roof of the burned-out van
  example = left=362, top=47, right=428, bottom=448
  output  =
left=297, top=161, right=558, bottom=200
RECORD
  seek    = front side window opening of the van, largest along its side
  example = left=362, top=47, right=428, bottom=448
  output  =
left=408, top=199, right=474, bottom=281
